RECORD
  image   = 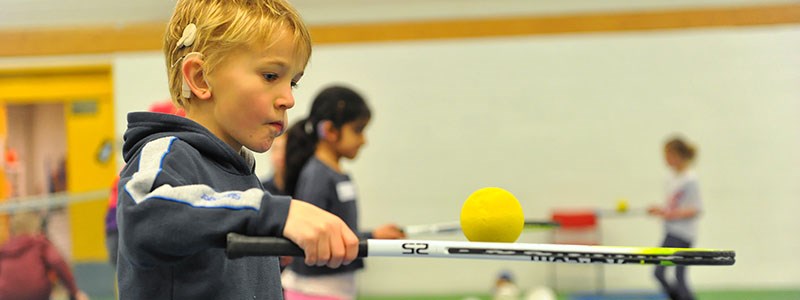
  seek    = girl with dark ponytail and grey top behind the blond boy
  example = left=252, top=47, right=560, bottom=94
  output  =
left=282, top=86, right=405, bottom=300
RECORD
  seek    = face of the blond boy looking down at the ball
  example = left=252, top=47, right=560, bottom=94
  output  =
left=203, top=31, right=305, bottom=152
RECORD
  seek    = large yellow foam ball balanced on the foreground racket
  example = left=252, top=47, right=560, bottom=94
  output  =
left=461, top=187, right=525, bottom=243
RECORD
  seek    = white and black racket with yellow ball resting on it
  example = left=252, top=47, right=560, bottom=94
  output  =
left=226, top=233, right=736, bottom=266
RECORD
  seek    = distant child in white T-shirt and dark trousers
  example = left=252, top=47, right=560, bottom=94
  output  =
left=648, top=138, right=702, bottom=300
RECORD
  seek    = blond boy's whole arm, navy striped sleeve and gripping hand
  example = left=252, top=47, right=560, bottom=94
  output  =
left=117, top=138, right=358, bottom=267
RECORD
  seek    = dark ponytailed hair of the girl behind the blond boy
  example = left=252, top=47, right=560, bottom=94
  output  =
left=284, top=86, right=372, bottom=196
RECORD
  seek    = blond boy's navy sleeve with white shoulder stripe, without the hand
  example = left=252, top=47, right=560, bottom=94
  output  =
left=117, top=137, right=291, bottom=266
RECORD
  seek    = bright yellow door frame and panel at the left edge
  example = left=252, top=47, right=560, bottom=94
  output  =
left=0, top=66, right=118, bottom=262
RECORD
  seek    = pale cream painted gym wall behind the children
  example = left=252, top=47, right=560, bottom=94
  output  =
left=113, top=26, right=800, bottom=294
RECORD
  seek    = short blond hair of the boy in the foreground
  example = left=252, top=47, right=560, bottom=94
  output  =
left=163, top=0, right=311, bottom=108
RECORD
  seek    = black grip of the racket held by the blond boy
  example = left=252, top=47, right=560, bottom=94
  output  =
left=225, top=232, right=367, bottom=259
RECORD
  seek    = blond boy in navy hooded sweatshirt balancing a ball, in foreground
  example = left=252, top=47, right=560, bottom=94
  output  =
left=117, top=0, right=358, bottom=299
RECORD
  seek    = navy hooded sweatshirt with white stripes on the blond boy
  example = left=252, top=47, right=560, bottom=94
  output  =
left=117, top=112, right=291, bottom=300
